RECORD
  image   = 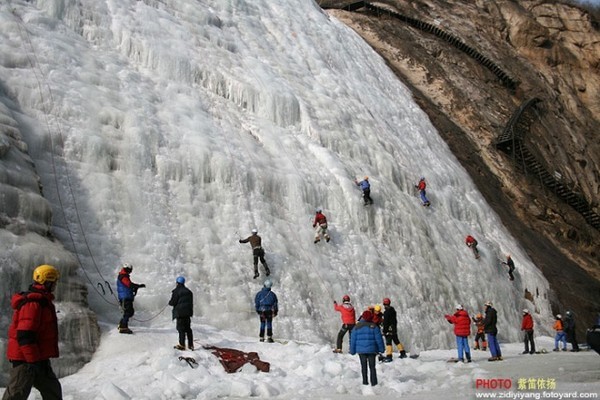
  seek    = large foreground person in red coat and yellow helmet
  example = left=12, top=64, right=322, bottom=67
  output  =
left=2, top=265, right=62, bottom=400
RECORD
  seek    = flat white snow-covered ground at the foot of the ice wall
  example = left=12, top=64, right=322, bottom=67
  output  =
left=54, top=320, right=600, bottom=400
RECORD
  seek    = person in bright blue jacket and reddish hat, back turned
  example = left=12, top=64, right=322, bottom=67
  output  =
left=350, top=310, right=385, bottom=386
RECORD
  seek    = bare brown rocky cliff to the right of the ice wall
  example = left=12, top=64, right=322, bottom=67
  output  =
left=320, top=0, right=600, bottom=333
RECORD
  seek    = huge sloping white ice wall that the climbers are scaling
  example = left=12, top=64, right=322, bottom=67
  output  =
left=0, top=0, right=550, bottom=364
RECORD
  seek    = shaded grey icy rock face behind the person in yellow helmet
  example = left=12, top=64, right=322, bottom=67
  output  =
left=0, top=94, right=100, bottom=386
